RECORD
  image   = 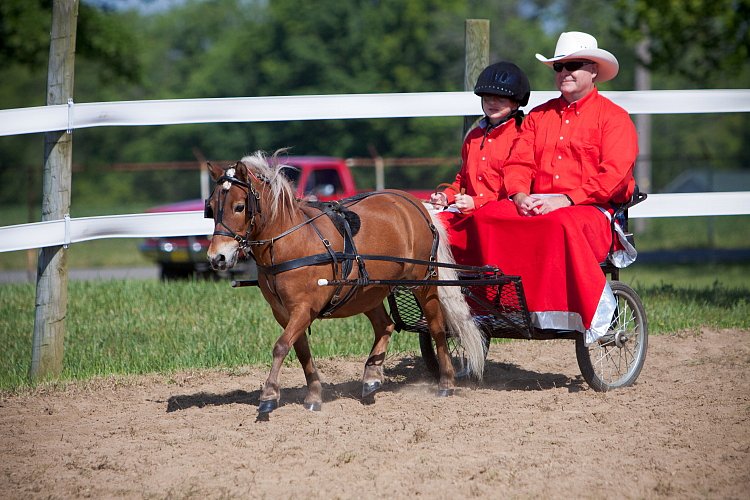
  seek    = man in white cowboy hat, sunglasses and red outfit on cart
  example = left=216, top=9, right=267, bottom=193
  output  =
left=472, top=32, right=638, bottom=344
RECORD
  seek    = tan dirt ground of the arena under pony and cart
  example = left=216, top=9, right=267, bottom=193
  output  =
left=0, top=331, right=750, bottom=499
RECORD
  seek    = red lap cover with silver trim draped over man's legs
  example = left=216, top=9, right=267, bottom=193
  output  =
left=470, top=200, right=614, bottom=340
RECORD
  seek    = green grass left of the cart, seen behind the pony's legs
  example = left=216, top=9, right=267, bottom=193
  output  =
left=0, top=280, right=418, bottom=390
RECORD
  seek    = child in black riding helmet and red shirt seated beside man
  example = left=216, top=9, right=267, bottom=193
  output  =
left=430, top=61, right=531, bottom=265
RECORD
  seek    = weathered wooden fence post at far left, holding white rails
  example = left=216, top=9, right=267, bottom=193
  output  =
left=30, top=0, right=78, bottom=382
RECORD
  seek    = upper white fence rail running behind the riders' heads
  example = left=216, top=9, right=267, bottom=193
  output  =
left=0, top=89, right=750, bottom=136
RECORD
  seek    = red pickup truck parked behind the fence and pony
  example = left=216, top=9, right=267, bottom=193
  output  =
left=140, top=156, right=429, bottom=279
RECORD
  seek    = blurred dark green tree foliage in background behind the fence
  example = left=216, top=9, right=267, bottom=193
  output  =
left=0, top=0, right=750, bottom=211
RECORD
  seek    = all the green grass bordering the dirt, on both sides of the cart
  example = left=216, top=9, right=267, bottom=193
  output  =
left=0, top=264, right=750, bottom=390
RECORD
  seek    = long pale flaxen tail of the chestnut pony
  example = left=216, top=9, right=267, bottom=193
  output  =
left=430, top=211, right=485, bottom=380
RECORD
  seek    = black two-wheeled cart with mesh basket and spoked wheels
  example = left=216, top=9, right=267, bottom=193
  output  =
left=388, top=192, right=648, bottom=392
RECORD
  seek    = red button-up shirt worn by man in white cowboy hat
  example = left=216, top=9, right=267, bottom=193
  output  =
left=504, top=88, right=638, bottom=205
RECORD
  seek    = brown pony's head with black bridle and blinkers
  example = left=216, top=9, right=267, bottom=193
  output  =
left=204, top=161, right=260, bottom=270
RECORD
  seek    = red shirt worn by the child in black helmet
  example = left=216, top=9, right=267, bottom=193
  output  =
left=445, top=118, right=519, bottom=209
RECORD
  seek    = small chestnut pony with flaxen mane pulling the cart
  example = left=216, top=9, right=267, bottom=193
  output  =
left=205, top=151, right=485, bottom=414
